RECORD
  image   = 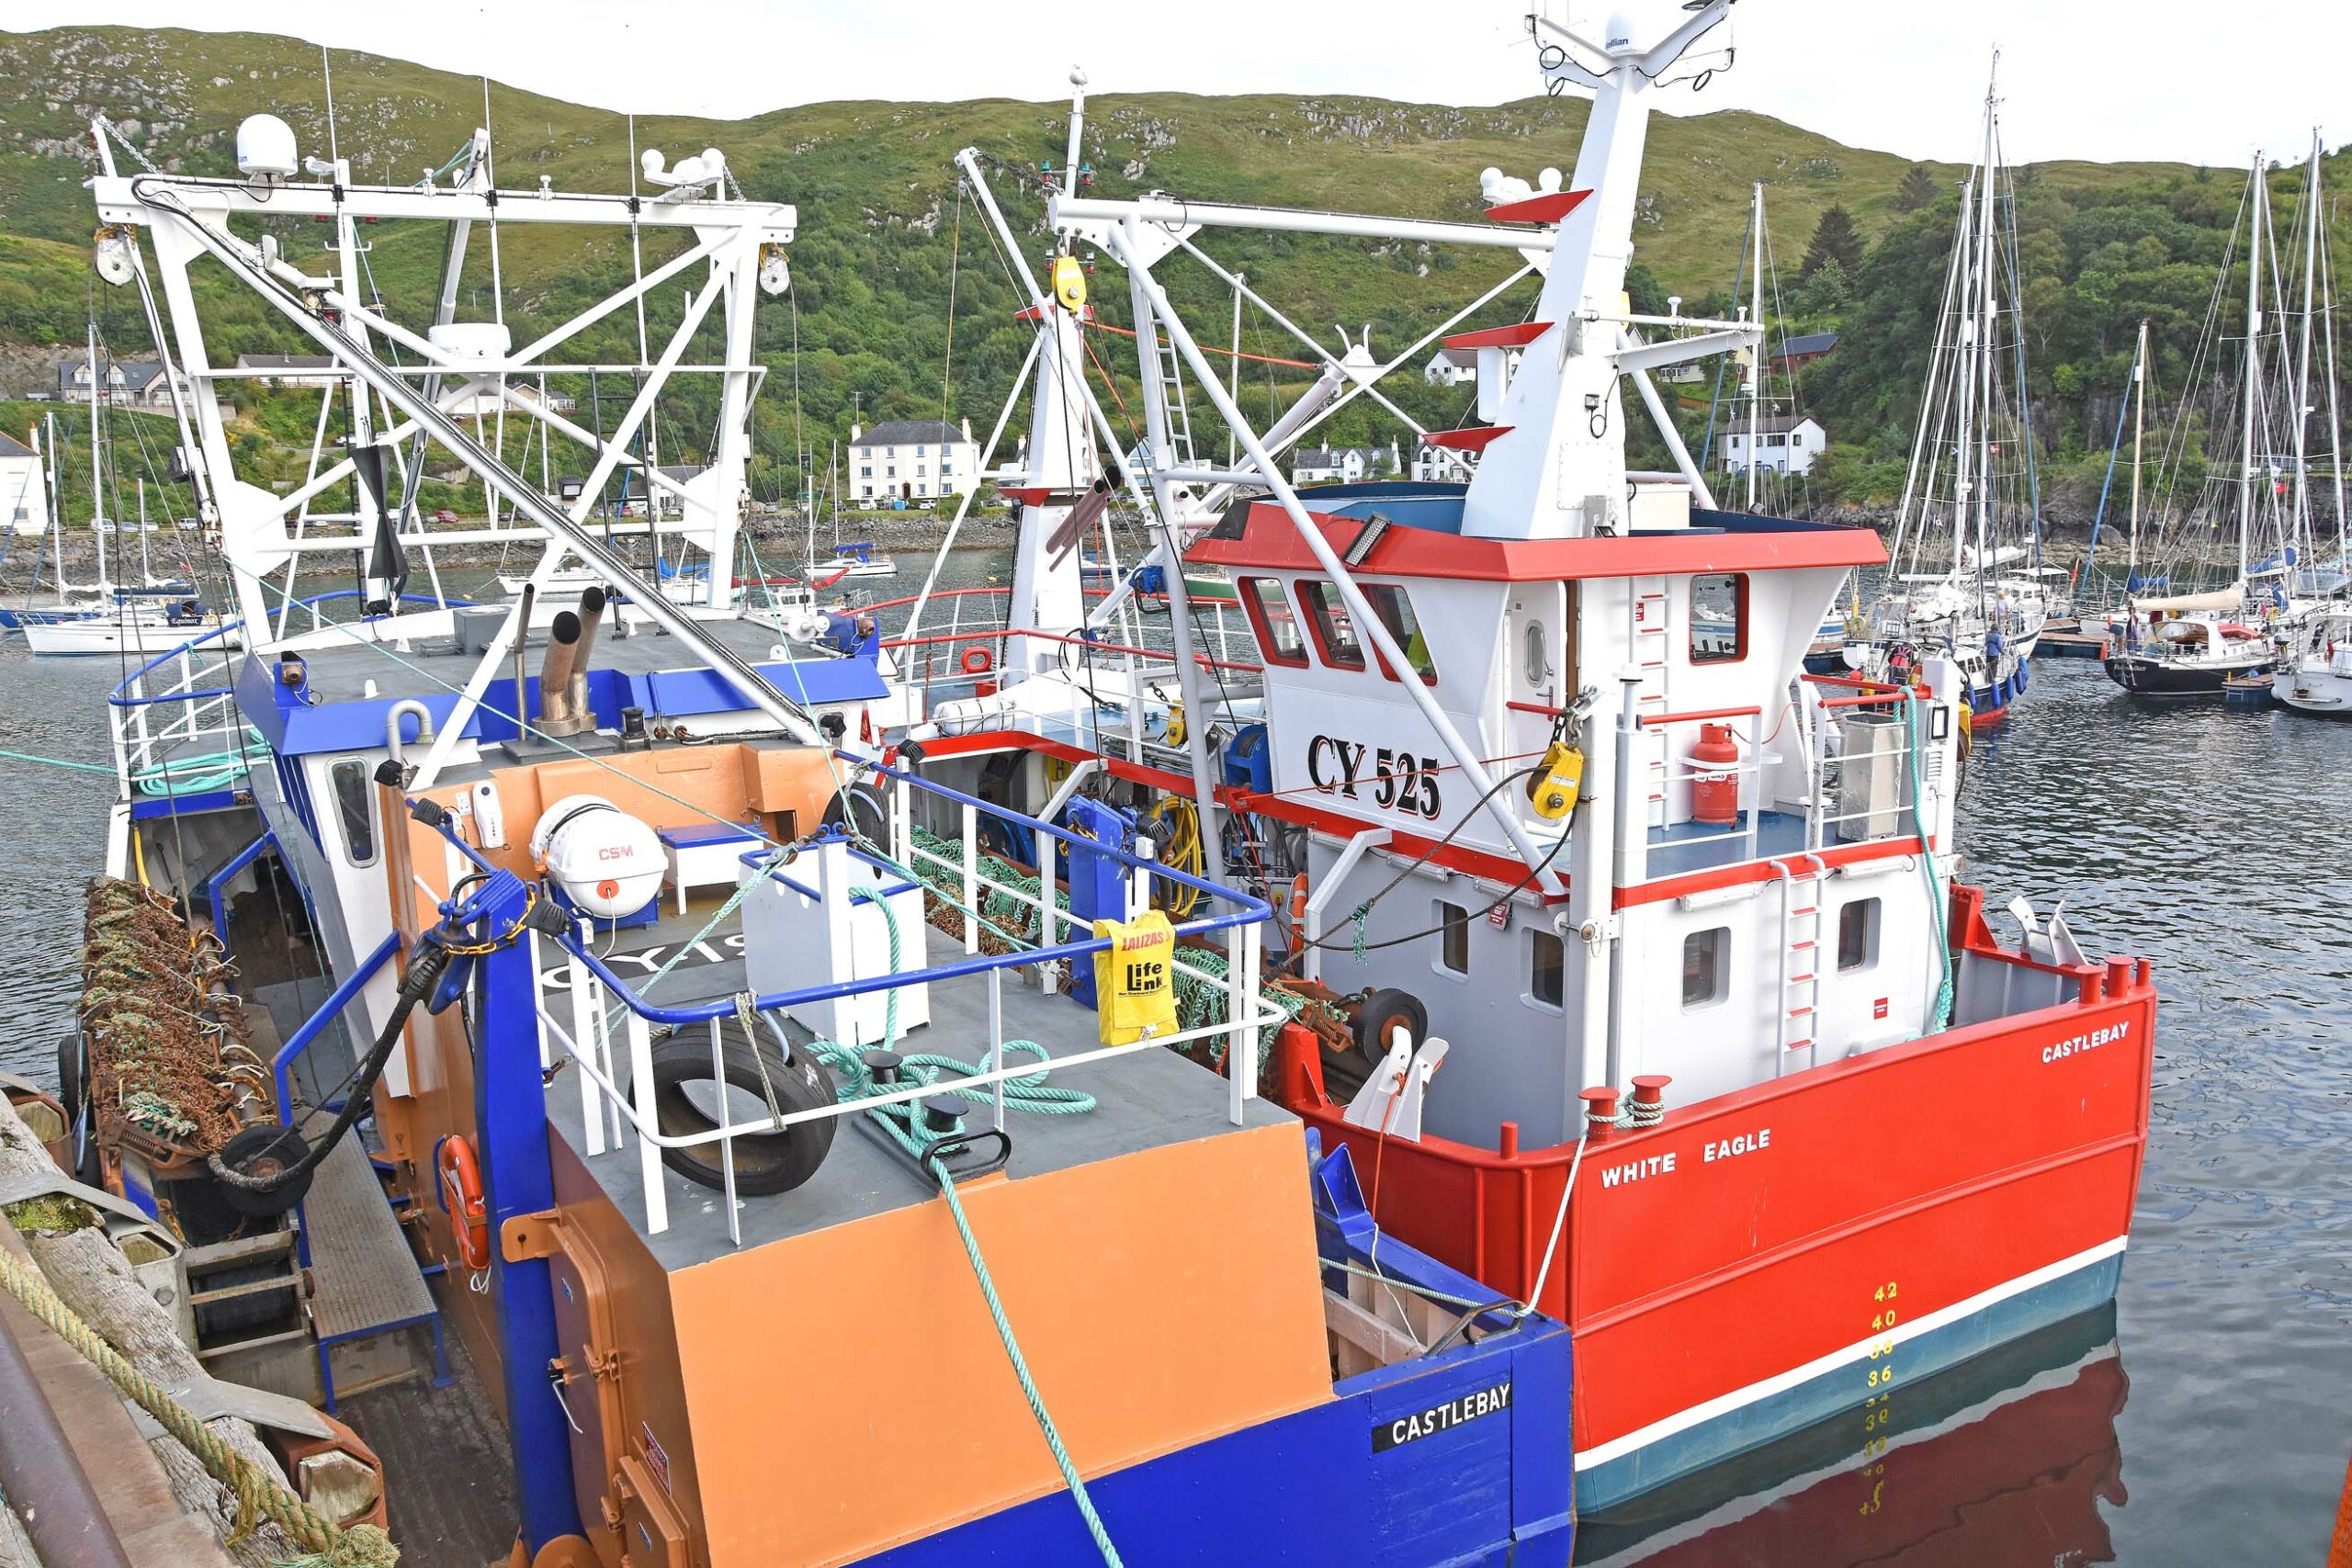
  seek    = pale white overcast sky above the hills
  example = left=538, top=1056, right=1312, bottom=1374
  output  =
left=7, top=0, right=2352, bottom=164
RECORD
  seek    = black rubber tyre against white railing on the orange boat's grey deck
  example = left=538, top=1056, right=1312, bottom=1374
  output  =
left=654, top=1022, right=840, bottom=1197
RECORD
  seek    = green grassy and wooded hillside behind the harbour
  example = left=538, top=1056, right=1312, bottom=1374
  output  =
left=0, top=28, right=2324, bottom=514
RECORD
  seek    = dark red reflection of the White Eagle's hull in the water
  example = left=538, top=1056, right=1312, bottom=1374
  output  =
left=1576, top=1303, right=2131, bottom=1568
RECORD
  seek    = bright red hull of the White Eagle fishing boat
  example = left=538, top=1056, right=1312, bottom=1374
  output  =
left=1284, top=891, right=2157, bottom=1485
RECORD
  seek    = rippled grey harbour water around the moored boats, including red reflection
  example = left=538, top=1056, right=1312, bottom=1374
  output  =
left=0, top=592, right=2352, bottom=1568
